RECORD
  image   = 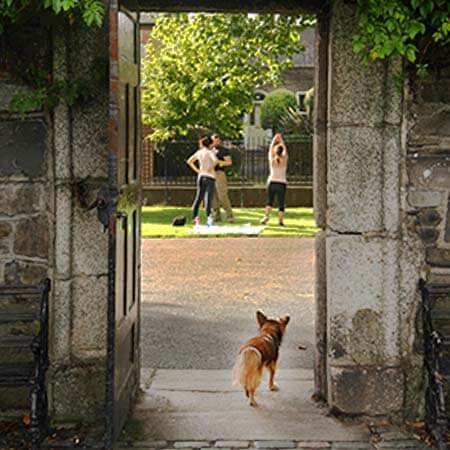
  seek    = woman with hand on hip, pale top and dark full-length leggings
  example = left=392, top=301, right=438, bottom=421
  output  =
left=186, top=137, right=220, bottom=225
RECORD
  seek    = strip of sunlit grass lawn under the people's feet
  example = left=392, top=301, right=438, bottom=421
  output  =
left=142, top=206, right=318, bottom=238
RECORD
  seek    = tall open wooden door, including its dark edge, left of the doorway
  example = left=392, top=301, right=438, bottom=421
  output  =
left=105, top=1, right=141, bottom=449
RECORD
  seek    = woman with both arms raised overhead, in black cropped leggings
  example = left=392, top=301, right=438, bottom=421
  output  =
left=260, top=133, right=288, bottom=226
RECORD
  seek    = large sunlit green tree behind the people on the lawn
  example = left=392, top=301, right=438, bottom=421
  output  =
left=142, top=14, right=312, bottom=140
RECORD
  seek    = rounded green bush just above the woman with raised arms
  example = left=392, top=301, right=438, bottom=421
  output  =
left=261, top=91, right=297, bottom=132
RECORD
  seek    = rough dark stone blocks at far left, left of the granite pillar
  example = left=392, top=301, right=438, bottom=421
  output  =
left=0, top=25, right=52, bottom=414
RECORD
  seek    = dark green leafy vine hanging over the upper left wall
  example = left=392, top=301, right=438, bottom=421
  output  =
left=0, top=0, right=105, bottom=113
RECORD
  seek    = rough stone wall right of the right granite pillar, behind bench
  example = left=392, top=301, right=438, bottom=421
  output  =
left=404, top=69, right=450, bottom=412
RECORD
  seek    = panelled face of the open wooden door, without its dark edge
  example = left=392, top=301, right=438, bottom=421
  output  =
left=115, top=4, right=140, bottom=436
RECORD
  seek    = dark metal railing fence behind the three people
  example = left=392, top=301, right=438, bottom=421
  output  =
left=150, top=135, right=313, bottom=186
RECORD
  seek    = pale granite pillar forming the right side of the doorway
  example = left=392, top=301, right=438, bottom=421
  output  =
left=326, top=1, right=420, bottom=416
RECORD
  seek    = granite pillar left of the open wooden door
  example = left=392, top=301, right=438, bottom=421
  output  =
left=50, top=21, right=109, bottom=422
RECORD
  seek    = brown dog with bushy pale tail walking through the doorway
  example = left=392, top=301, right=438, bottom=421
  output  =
left=233, top=311, right=289, bottom=406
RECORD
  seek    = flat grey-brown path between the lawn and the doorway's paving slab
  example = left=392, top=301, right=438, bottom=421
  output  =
left=141, top=237, right=314, bottom=369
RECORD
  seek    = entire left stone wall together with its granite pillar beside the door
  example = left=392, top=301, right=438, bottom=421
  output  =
left=0, top=17, right=109, bottom=421
